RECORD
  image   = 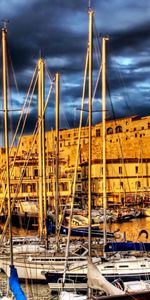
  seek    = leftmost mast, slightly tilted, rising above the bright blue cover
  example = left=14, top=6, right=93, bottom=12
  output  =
left=2, top=24, right=13, bottom=266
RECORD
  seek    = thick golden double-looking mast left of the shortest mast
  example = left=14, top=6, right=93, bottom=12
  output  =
left=38, top=58, right=44, bottom=237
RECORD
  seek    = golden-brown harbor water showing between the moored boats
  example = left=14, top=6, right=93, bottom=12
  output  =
left=0, top=217, right=150, bottom=300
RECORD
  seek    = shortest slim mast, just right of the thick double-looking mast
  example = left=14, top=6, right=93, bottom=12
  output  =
left=55, top=73, right=60, bottom=250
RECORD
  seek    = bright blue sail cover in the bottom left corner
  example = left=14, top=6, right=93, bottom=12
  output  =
left=9, top=266, right=27, bottom=300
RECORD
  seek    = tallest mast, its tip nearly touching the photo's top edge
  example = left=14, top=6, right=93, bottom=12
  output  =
left=88, top=8, right=94, bottom=256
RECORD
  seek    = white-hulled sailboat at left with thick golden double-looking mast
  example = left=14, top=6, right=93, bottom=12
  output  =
left=0, top=58, right=87, bottom=281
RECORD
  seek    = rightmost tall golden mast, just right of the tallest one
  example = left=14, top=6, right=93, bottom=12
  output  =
left=102, top=37, right=108, bottom=251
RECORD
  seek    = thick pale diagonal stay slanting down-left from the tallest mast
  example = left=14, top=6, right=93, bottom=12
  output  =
left=62, top=47, right=89, bottom=287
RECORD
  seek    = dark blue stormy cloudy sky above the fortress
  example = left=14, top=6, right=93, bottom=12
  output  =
left=0, top=0, right=150, bottom=139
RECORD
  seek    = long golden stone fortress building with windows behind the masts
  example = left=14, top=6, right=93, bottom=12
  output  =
left=0, top=116, right=150, bottom=211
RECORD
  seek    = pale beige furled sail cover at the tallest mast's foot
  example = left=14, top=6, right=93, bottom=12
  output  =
left=87, top=258, right=125, bottom=296
